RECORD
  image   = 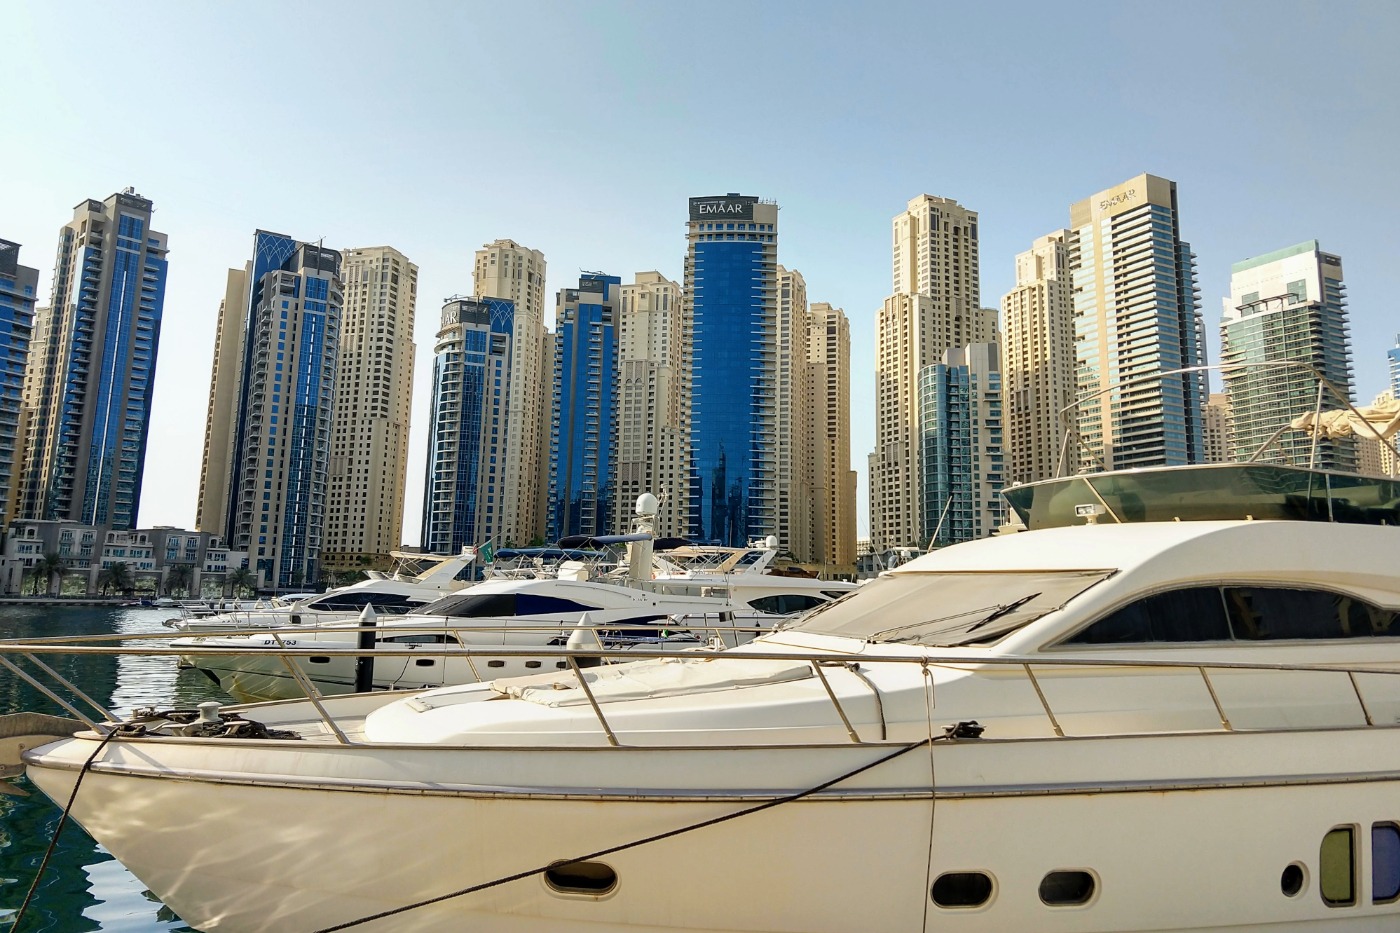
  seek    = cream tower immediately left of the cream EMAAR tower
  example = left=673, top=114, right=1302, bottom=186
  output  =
left=1001, top=230, right=1074, bottom=483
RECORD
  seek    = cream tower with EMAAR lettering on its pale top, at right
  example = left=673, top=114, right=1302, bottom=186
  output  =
left=1065, top=175, right=1207, bottom=469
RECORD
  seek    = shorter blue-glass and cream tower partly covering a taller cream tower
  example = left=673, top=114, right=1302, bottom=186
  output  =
left=423, top=297, right=517, bottom=553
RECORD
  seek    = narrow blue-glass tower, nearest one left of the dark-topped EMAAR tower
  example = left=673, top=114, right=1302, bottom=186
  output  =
left=547, top=272, right=627, bottom=541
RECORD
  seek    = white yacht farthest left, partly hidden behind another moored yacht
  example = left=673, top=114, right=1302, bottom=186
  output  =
left=165, top=548, right=476, bottom=633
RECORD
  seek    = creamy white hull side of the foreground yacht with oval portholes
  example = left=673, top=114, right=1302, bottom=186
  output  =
left=21, top=730, right=1400, bottom=933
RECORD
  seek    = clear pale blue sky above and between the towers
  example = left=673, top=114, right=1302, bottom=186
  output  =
left=0, top=0, right=1400, bottom=542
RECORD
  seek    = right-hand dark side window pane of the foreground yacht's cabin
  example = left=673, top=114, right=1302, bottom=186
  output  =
left=1225, top=587, right=1400, bottom=640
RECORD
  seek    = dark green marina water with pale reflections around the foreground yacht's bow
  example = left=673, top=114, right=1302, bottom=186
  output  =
left=0, top=607, right=230, bottom=933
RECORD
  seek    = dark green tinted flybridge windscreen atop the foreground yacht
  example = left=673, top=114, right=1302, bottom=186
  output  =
left=1002, top=464, right=1400, bottom=531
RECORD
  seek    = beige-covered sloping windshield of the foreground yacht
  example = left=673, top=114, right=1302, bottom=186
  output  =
left=788, top=570, right=1116, bottom=647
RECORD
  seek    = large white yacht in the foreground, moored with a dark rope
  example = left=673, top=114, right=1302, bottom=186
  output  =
left=8, top=465, right=1400, bottom=933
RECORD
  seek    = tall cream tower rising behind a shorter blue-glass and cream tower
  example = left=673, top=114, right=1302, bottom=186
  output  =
left=475, top=240, right=553, bottom=545
